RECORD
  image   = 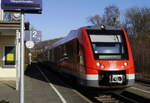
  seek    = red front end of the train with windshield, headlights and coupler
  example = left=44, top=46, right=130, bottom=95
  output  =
left=82, top=26, right=135, bottom=88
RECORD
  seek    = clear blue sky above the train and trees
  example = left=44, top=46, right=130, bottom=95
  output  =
left=25, top=0, right=150, bottom=40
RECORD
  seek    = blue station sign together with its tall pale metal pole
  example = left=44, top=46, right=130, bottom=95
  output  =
left=1, top=0, right=42, bottom=103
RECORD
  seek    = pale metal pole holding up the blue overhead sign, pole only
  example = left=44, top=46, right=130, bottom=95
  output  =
left=20, top=13, right=24, bottom=103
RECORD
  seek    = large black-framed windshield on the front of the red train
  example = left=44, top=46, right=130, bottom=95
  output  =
left=88, top=30, right=128, bottom=60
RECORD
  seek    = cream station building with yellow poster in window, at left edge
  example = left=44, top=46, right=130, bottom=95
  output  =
left=0, top=10, right=20, bottom=80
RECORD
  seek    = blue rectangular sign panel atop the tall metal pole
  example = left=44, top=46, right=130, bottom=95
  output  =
left=1, top=0, right=42, bottom=13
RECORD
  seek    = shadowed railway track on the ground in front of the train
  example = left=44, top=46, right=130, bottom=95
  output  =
left=78, top=86, right=150, bottom=103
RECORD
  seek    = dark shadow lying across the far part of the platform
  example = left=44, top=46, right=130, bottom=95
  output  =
left=25, top=63, right=72, bottom=88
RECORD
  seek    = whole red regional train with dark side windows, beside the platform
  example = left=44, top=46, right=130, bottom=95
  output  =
left=40, top=25, right=135, bottom=88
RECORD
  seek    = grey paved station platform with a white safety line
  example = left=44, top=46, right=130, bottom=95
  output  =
left=0, top=64, right=90, bottom=103
